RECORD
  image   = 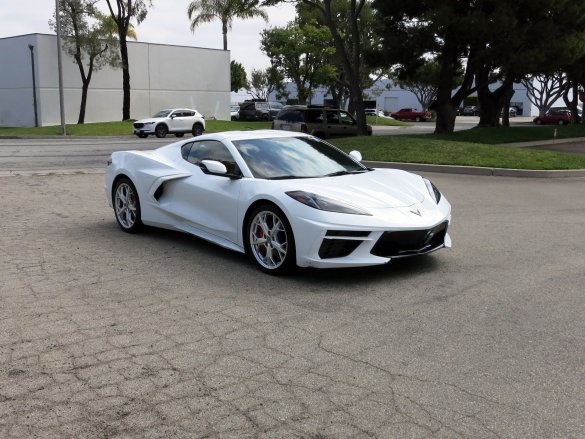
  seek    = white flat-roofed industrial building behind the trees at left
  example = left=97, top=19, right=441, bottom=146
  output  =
left=0, top=34, right=230, bottom=127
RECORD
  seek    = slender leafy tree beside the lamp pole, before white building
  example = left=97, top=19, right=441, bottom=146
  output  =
left=49, top=0, right=120, bottom=124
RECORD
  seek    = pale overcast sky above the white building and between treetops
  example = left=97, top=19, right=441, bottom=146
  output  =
left=0, top=0, right=294, bottom=75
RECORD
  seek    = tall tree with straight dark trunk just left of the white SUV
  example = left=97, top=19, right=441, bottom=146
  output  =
left=106, top=0, right=152, bottom=120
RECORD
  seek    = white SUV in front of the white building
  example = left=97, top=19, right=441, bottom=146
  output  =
left=134, top=108, right=205, bottom=138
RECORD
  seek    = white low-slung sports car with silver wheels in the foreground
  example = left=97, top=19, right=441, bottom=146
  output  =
left=105, top=130, right=451, bottom=274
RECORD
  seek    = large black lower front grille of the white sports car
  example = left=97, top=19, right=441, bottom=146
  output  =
left=371, top=221, right=448, bottom=258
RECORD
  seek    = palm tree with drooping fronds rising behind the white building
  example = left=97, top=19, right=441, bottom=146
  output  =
left=187, top=0, right=268, bottom=50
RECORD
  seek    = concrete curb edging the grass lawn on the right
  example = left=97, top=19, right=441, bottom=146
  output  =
left=362, top=161, right=585, bottom=178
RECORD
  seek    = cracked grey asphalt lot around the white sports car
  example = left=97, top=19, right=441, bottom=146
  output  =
left=0, top=168, right=585, bottom=439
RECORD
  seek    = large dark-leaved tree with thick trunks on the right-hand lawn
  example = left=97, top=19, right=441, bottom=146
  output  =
left=374, top=0, right=585, bottom=133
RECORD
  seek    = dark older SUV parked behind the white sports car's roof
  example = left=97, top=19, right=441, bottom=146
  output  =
left=272, top=105, right=372, bottom=138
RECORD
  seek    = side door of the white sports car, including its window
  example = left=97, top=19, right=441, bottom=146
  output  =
left=165, top=140, right=242, bottom=243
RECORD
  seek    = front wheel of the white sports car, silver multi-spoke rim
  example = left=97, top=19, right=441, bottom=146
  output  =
left=244, top=204, right=296, bottom=275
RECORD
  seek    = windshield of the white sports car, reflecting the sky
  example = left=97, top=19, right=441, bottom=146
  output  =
left=233, top=137, right=368, bottom=180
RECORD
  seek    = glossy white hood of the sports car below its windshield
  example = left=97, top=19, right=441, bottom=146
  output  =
left=274, top=169, right=426, bottom=209
